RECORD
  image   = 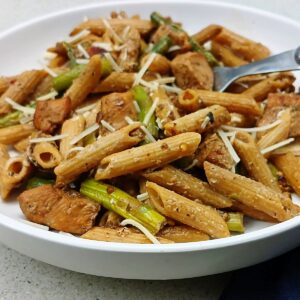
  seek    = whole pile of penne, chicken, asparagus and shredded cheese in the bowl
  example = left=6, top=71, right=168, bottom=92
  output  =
left=0, top=12, right=300, bottom=244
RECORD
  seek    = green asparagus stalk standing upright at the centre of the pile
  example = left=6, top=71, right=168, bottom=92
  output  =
left=132, top=85, right=158, bottom=143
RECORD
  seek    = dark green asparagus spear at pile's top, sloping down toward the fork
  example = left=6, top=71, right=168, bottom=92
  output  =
left=151, top=12, right=220, bottom=66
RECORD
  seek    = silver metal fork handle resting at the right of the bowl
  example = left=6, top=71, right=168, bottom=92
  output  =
left=232, top=47, right=300, bottom=78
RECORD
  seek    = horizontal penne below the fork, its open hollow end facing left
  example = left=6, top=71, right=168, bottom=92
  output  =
left=178, top=89, right=262, bottom=116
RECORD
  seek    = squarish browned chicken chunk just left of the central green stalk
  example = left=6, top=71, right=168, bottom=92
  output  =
left=98, top=92, right=137, bottom=135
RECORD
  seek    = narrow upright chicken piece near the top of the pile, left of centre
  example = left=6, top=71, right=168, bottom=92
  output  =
left=118, top=27, right=141, bottom=72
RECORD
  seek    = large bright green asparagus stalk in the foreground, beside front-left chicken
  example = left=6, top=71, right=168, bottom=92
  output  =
left=80, top=179, right=166, bottom=234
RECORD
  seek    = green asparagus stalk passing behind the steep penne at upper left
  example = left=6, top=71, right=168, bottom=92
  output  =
left=53, top=57, right=112, bottom=92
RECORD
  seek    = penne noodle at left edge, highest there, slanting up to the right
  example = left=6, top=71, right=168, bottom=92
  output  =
left=0, top=70, right=47, bottom=115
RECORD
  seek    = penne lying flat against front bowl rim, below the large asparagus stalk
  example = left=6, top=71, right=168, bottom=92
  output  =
left=81, top=227, right=174, bottom=244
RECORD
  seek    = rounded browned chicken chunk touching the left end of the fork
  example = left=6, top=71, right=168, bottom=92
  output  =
left=171, top=52, right=214, bottom=90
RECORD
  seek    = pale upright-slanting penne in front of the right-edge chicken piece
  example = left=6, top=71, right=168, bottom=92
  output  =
left=257, top=108, right=291, bottom=157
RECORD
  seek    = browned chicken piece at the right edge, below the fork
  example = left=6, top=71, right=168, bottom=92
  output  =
left=258, top=94, right=300, bottom=137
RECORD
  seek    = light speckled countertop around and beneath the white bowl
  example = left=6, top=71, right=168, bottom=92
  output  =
left=0, top=0, right=300, bottom=300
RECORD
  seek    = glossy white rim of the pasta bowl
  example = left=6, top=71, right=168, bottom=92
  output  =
left=0, top=0, right=300, bottom=253
